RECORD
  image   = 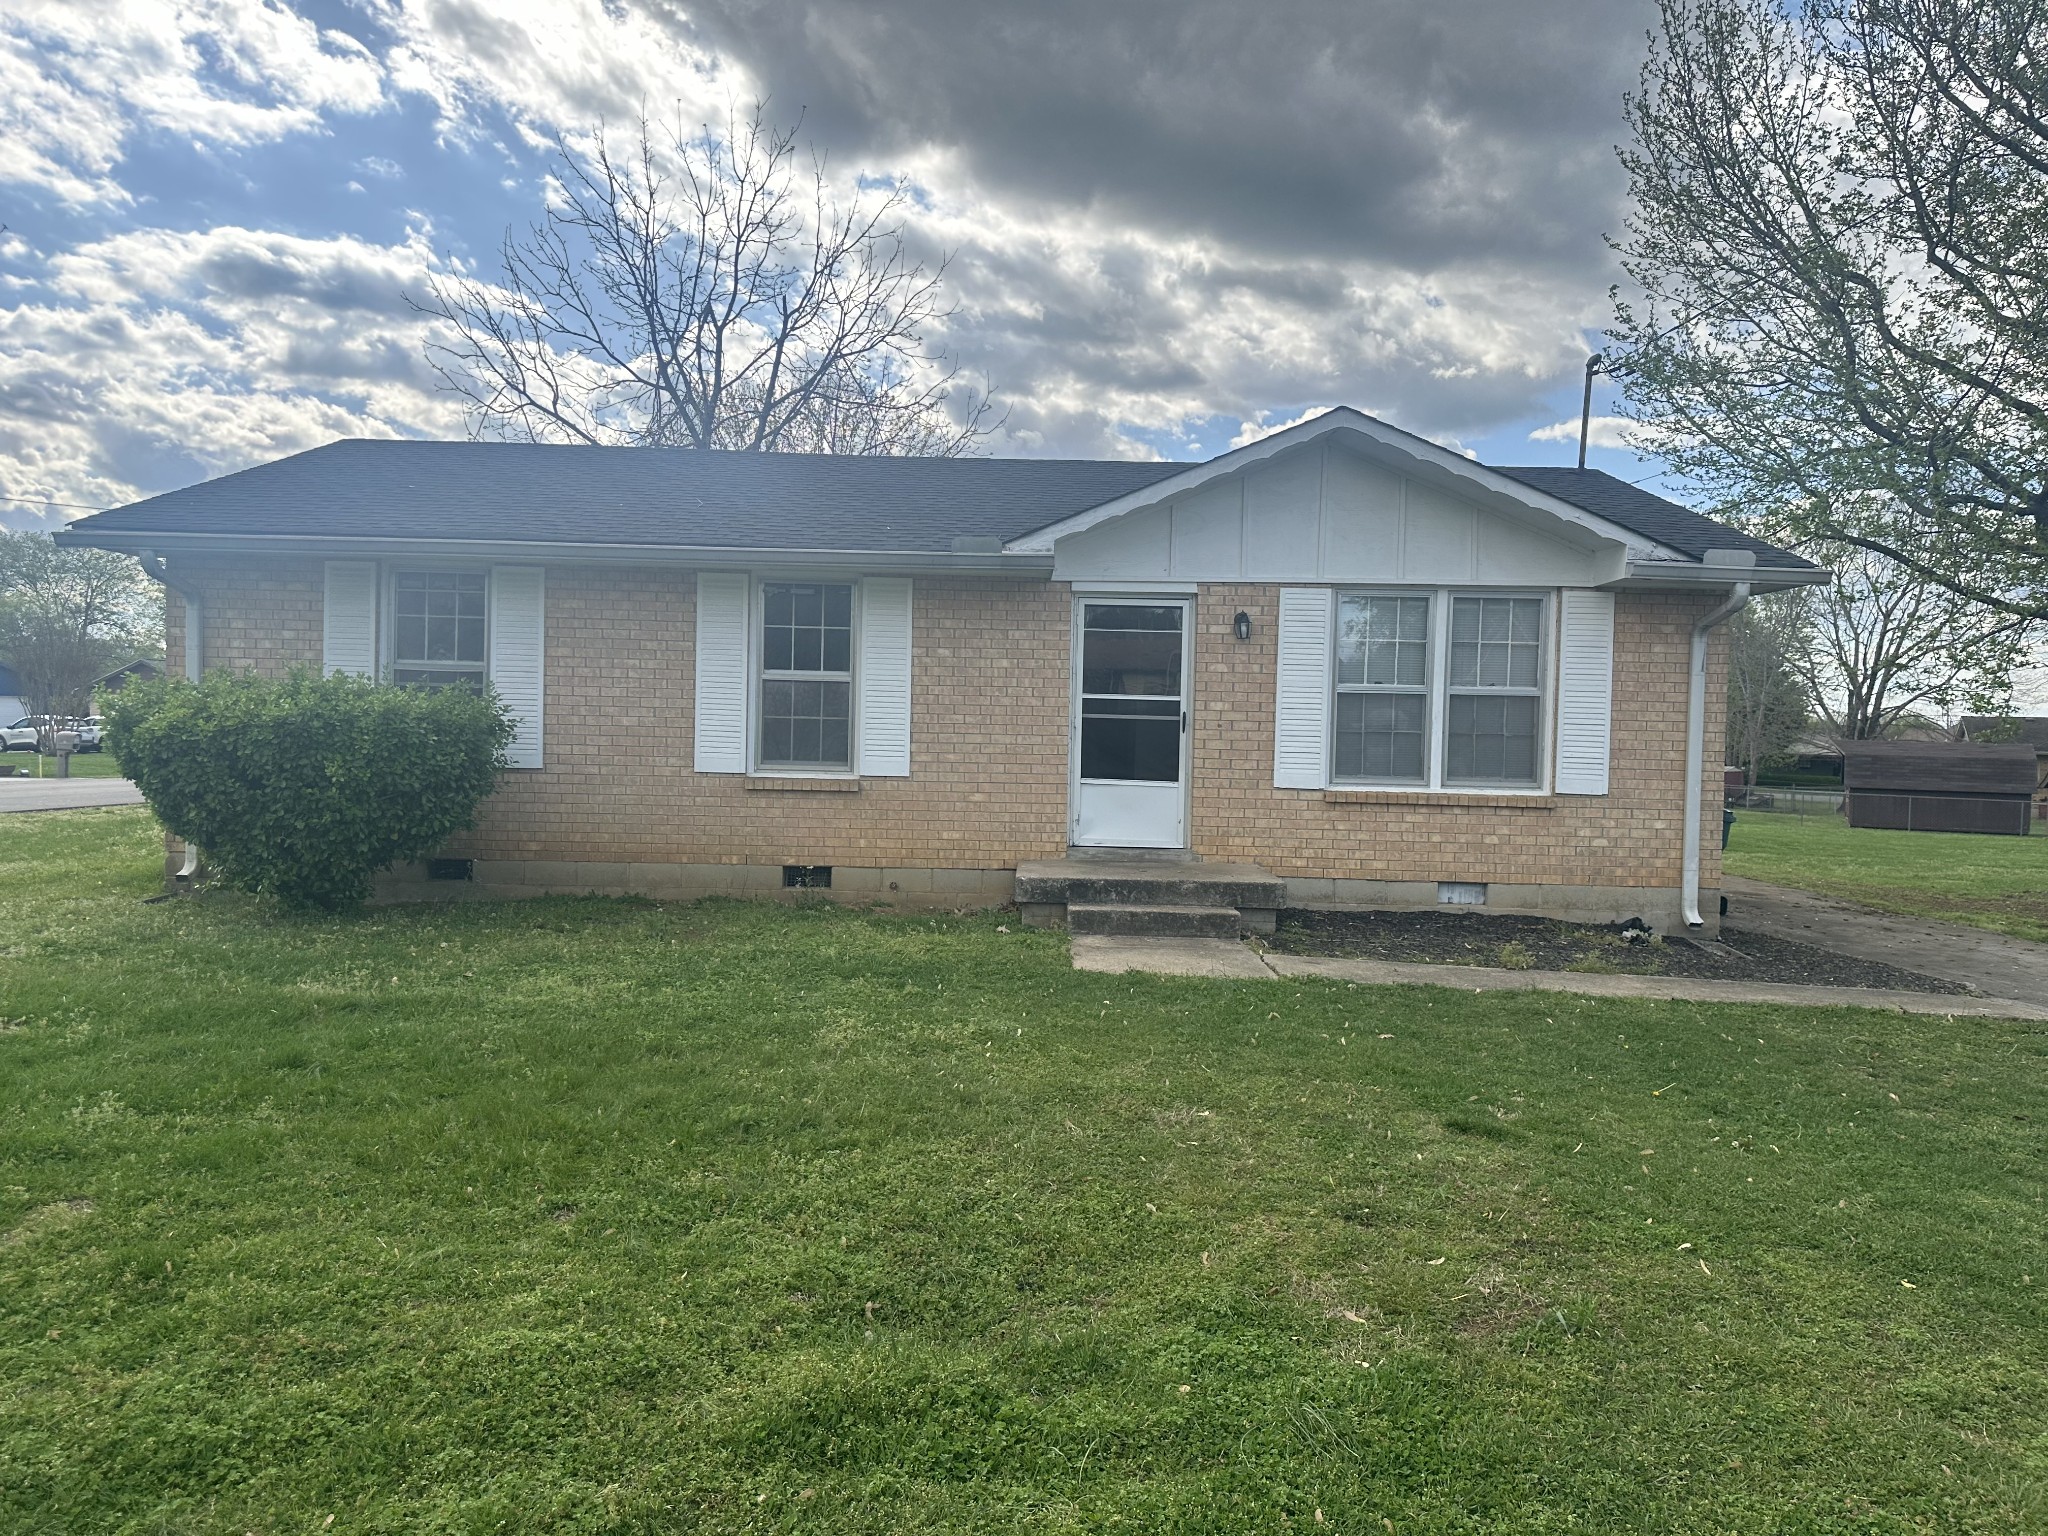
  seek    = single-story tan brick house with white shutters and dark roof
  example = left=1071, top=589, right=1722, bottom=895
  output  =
left=59, top=410, right=1827, bottom=928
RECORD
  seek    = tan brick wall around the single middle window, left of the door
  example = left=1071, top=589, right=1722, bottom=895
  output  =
left=461, top=567, right=1069, bottom=868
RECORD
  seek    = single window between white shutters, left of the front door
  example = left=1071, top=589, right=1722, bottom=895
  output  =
left=756, top=582, right=854, bottom=772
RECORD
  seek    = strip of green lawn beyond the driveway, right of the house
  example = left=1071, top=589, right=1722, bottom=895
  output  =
left=1724, top=811, right=2048, bottom=942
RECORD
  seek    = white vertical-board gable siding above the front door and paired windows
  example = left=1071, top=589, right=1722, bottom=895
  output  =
left=1053, top=442, right=1620, bottom=588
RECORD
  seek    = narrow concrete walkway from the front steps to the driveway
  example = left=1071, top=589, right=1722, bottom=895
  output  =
left=1073, top=937, right=2048, bottom=1020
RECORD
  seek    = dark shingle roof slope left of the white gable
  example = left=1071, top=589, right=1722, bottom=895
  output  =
left=72, top=438, right=1186, bottom=553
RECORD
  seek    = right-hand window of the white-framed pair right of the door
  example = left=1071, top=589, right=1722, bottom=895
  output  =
left=1444, top=596, right=1542, bottom=784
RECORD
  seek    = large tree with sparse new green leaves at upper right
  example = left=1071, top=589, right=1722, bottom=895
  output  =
left=1614, top=0, right=2048, bottom=618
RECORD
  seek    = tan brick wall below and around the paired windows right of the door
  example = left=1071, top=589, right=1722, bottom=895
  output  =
left=1192, top=584, right=1724, bottom=887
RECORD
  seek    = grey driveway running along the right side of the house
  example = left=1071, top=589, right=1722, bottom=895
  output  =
left=1720, top=874, right=2048, bottom=1004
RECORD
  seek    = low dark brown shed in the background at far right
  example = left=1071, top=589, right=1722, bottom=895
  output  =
left=1843, top=741, right=2038, bottom=836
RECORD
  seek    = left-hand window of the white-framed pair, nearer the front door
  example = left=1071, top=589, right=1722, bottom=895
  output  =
left=1333, top=592, right=1430, bottom=784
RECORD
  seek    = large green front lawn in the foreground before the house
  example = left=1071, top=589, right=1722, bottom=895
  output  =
left=12, top=811, right=2048, bottom=1536
